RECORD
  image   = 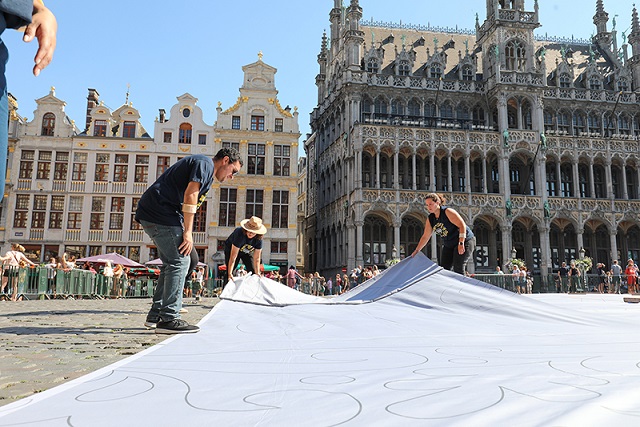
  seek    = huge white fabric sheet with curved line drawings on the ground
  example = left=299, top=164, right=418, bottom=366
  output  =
left=0, top=255, right=640, bottom=427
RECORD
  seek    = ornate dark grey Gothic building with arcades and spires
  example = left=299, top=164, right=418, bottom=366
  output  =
left=305, top=0, right=640, bottom=274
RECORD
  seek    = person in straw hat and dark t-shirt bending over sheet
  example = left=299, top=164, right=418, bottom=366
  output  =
left=224, top=216, right=267, bottom=280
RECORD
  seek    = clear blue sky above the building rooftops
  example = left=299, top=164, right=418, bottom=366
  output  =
left=3, top=0, right=633, bottom=154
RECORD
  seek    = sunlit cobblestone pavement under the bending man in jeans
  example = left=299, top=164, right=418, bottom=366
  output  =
left=0, top=298, right=219, bottom=406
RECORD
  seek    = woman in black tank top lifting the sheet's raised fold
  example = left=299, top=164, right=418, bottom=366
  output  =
left=411, top=193, right=476, bottom=274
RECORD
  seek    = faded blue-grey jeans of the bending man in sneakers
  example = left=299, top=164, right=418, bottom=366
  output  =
left=140, top=220, right=191, bottom=322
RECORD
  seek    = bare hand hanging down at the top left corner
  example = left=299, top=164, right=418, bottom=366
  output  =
left=22, top=1, right=58, bottom=77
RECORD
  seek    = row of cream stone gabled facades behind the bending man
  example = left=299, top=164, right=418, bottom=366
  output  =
left=0, top=55, right=300, bottom=269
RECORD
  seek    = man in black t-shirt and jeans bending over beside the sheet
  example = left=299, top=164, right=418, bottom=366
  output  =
left=136, top=148, right=242, bottom=334
